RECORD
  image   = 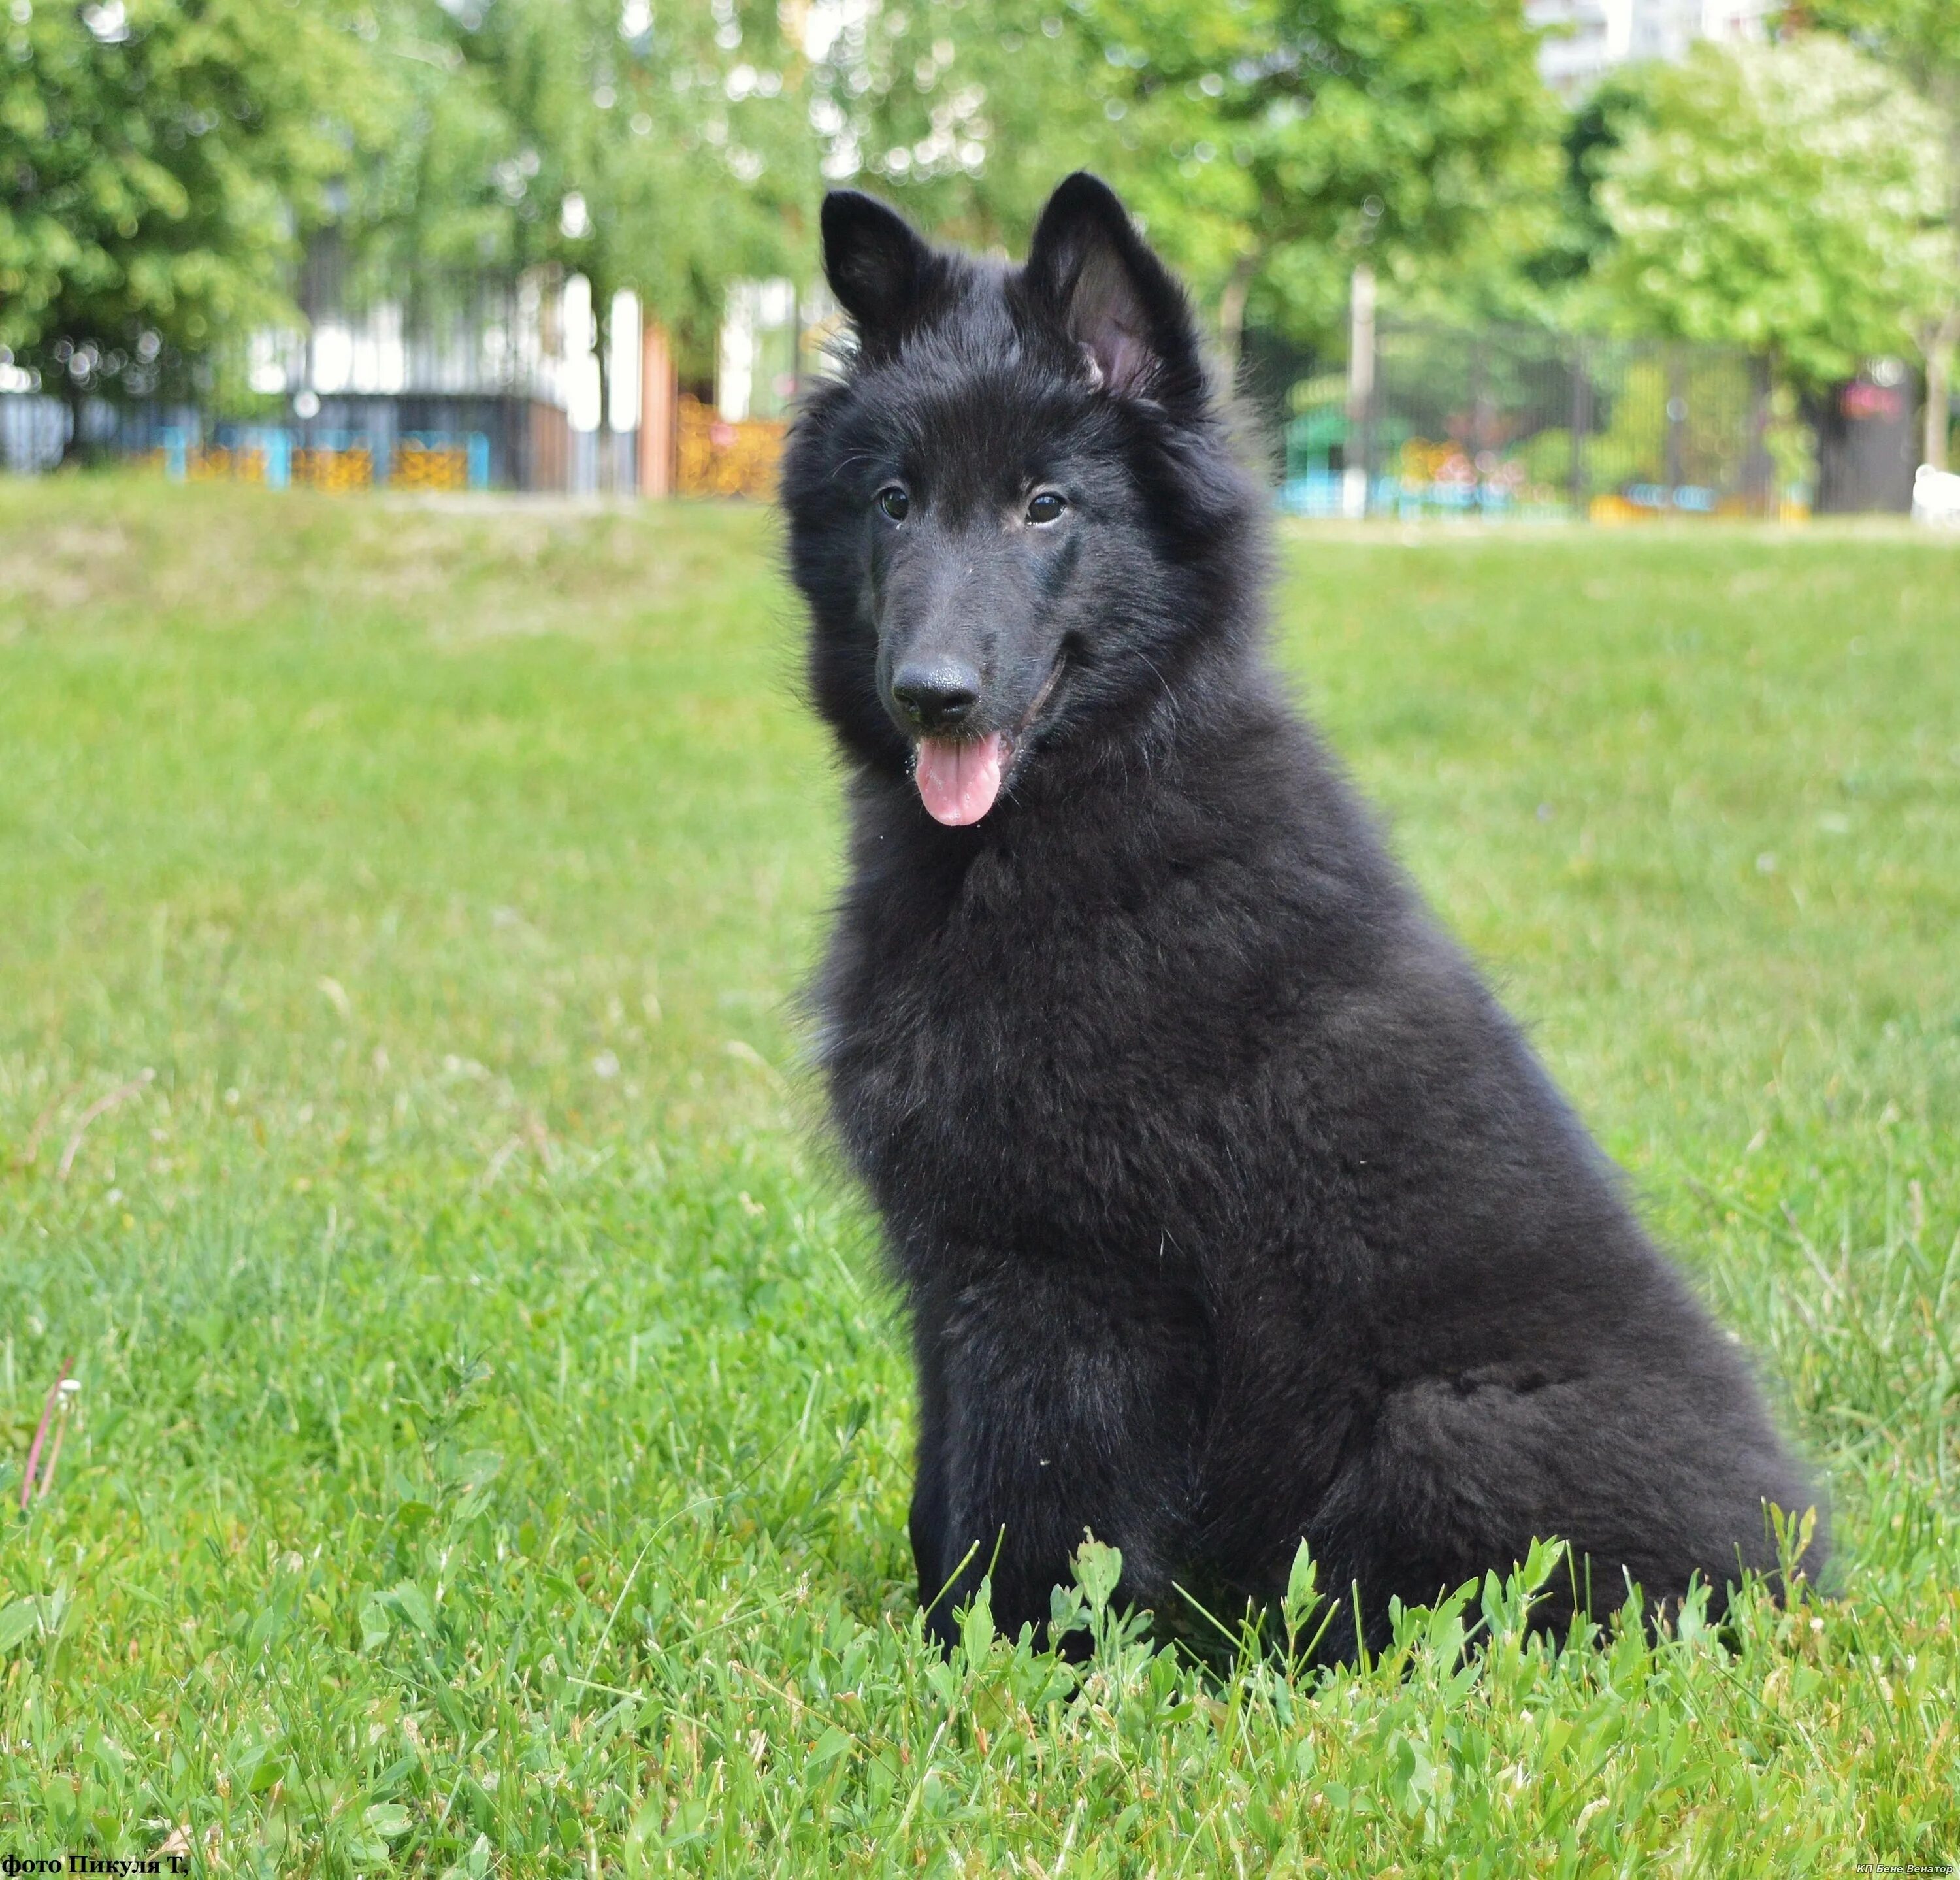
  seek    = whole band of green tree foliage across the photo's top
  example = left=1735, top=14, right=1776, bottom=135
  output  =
left=15, top=0, right=1960, bottom=412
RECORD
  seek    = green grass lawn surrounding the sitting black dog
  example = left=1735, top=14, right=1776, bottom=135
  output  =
left=0, top=480, right=1960, bottom=1880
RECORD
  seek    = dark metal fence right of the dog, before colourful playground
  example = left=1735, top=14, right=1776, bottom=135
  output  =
left=1258, top=322, right=1817, bottom=521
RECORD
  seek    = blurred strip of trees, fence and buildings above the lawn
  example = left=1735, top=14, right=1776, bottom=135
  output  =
left=0, top=0, right=1960, bottom=521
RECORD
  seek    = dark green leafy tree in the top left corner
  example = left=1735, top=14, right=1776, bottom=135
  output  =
left=0, top=0, right=372, bottom=449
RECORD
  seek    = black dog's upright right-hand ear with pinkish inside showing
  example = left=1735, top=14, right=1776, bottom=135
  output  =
left=1027, top=171, right=1203, bottom=404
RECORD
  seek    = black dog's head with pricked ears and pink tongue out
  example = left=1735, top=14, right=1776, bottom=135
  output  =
left=784, top=174, right=1256, bottom=823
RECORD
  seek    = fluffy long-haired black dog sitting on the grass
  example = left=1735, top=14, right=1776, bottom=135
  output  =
left=784, top=174, right=1823, bottom=1651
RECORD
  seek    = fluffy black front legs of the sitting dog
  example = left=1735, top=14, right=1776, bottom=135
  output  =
left=913, top=1262, right=1211, bottom=1643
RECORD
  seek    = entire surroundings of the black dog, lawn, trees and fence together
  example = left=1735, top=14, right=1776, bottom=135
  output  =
left=0, top=0, right=1960, bottom=1880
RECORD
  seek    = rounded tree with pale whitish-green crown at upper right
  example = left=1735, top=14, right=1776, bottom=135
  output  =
left=1595, top=33, right=1952, bottom=390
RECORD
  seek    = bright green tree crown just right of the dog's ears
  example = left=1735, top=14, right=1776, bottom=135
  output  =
left=1078, top=0, right=1560, bottom=353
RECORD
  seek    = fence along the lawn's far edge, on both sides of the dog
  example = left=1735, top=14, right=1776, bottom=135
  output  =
left=11, top=320, right=1915, bottom=521
